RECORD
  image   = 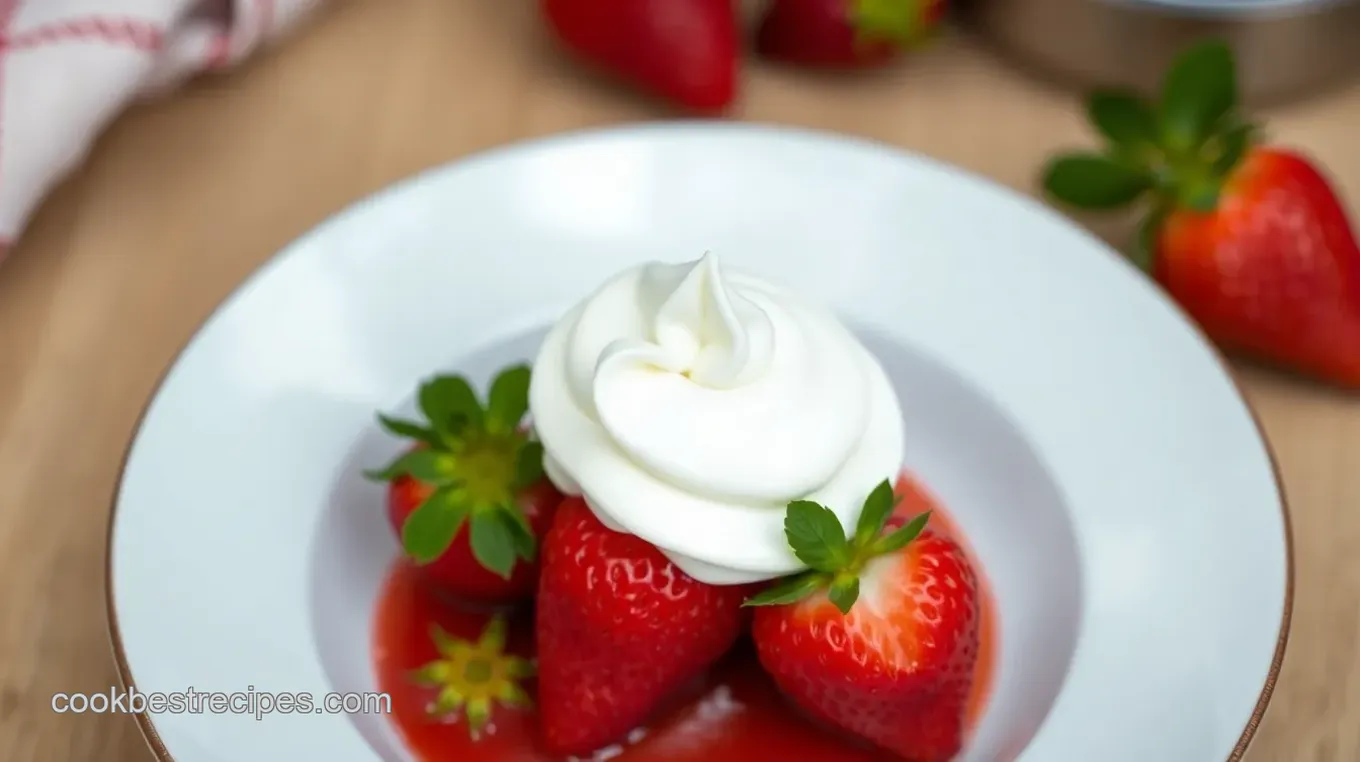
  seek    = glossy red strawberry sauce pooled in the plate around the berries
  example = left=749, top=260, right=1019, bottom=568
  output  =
left=374, top=475, right=997, bottom=762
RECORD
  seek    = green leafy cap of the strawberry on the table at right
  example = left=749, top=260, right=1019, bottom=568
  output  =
left=1042, top=39, right=1261, bottom=269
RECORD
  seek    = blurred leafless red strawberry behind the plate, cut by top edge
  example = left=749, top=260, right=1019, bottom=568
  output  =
left=540, top=0, right=740, bottom=112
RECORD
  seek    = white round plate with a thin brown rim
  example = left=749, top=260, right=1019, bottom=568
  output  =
left=109, top=125, right=1292, bottom=762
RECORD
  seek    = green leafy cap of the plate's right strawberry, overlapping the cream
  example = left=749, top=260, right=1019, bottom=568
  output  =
left=743, top=479, right=930, bottom=614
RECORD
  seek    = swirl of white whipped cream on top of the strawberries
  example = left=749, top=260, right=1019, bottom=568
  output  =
left=529, top=254, right=903, bottom=584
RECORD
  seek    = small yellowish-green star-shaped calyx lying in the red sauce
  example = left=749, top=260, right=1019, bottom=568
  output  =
left=411, top=616, right=536, bottom=740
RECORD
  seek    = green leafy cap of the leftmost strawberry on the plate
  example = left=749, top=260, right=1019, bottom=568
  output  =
left=366, top=365, right=543, bottom=580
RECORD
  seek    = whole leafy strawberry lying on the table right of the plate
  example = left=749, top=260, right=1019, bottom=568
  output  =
left=1043, top=41, right=1360, bottom=388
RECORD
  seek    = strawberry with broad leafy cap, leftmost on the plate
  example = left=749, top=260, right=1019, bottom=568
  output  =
left=369, top=366, right=562, bottom=603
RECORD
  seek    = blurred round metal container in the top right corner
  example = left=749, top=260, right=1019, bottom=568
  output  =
left=964, top=0, right=1360, bottom=103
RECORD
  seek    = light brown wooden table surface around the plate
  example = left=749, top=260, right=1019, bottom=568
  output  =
left=0, top=0, right=1360, bottom=762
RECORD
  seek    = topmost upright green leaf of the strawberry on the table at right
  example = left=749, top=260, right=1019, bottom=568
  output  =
left=1161, top=39, right=1238, bottom=152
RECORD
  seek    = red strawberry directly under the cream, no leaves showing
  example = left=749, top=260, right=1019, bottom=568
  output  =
left=534, top=498, right=747, bottom=755
